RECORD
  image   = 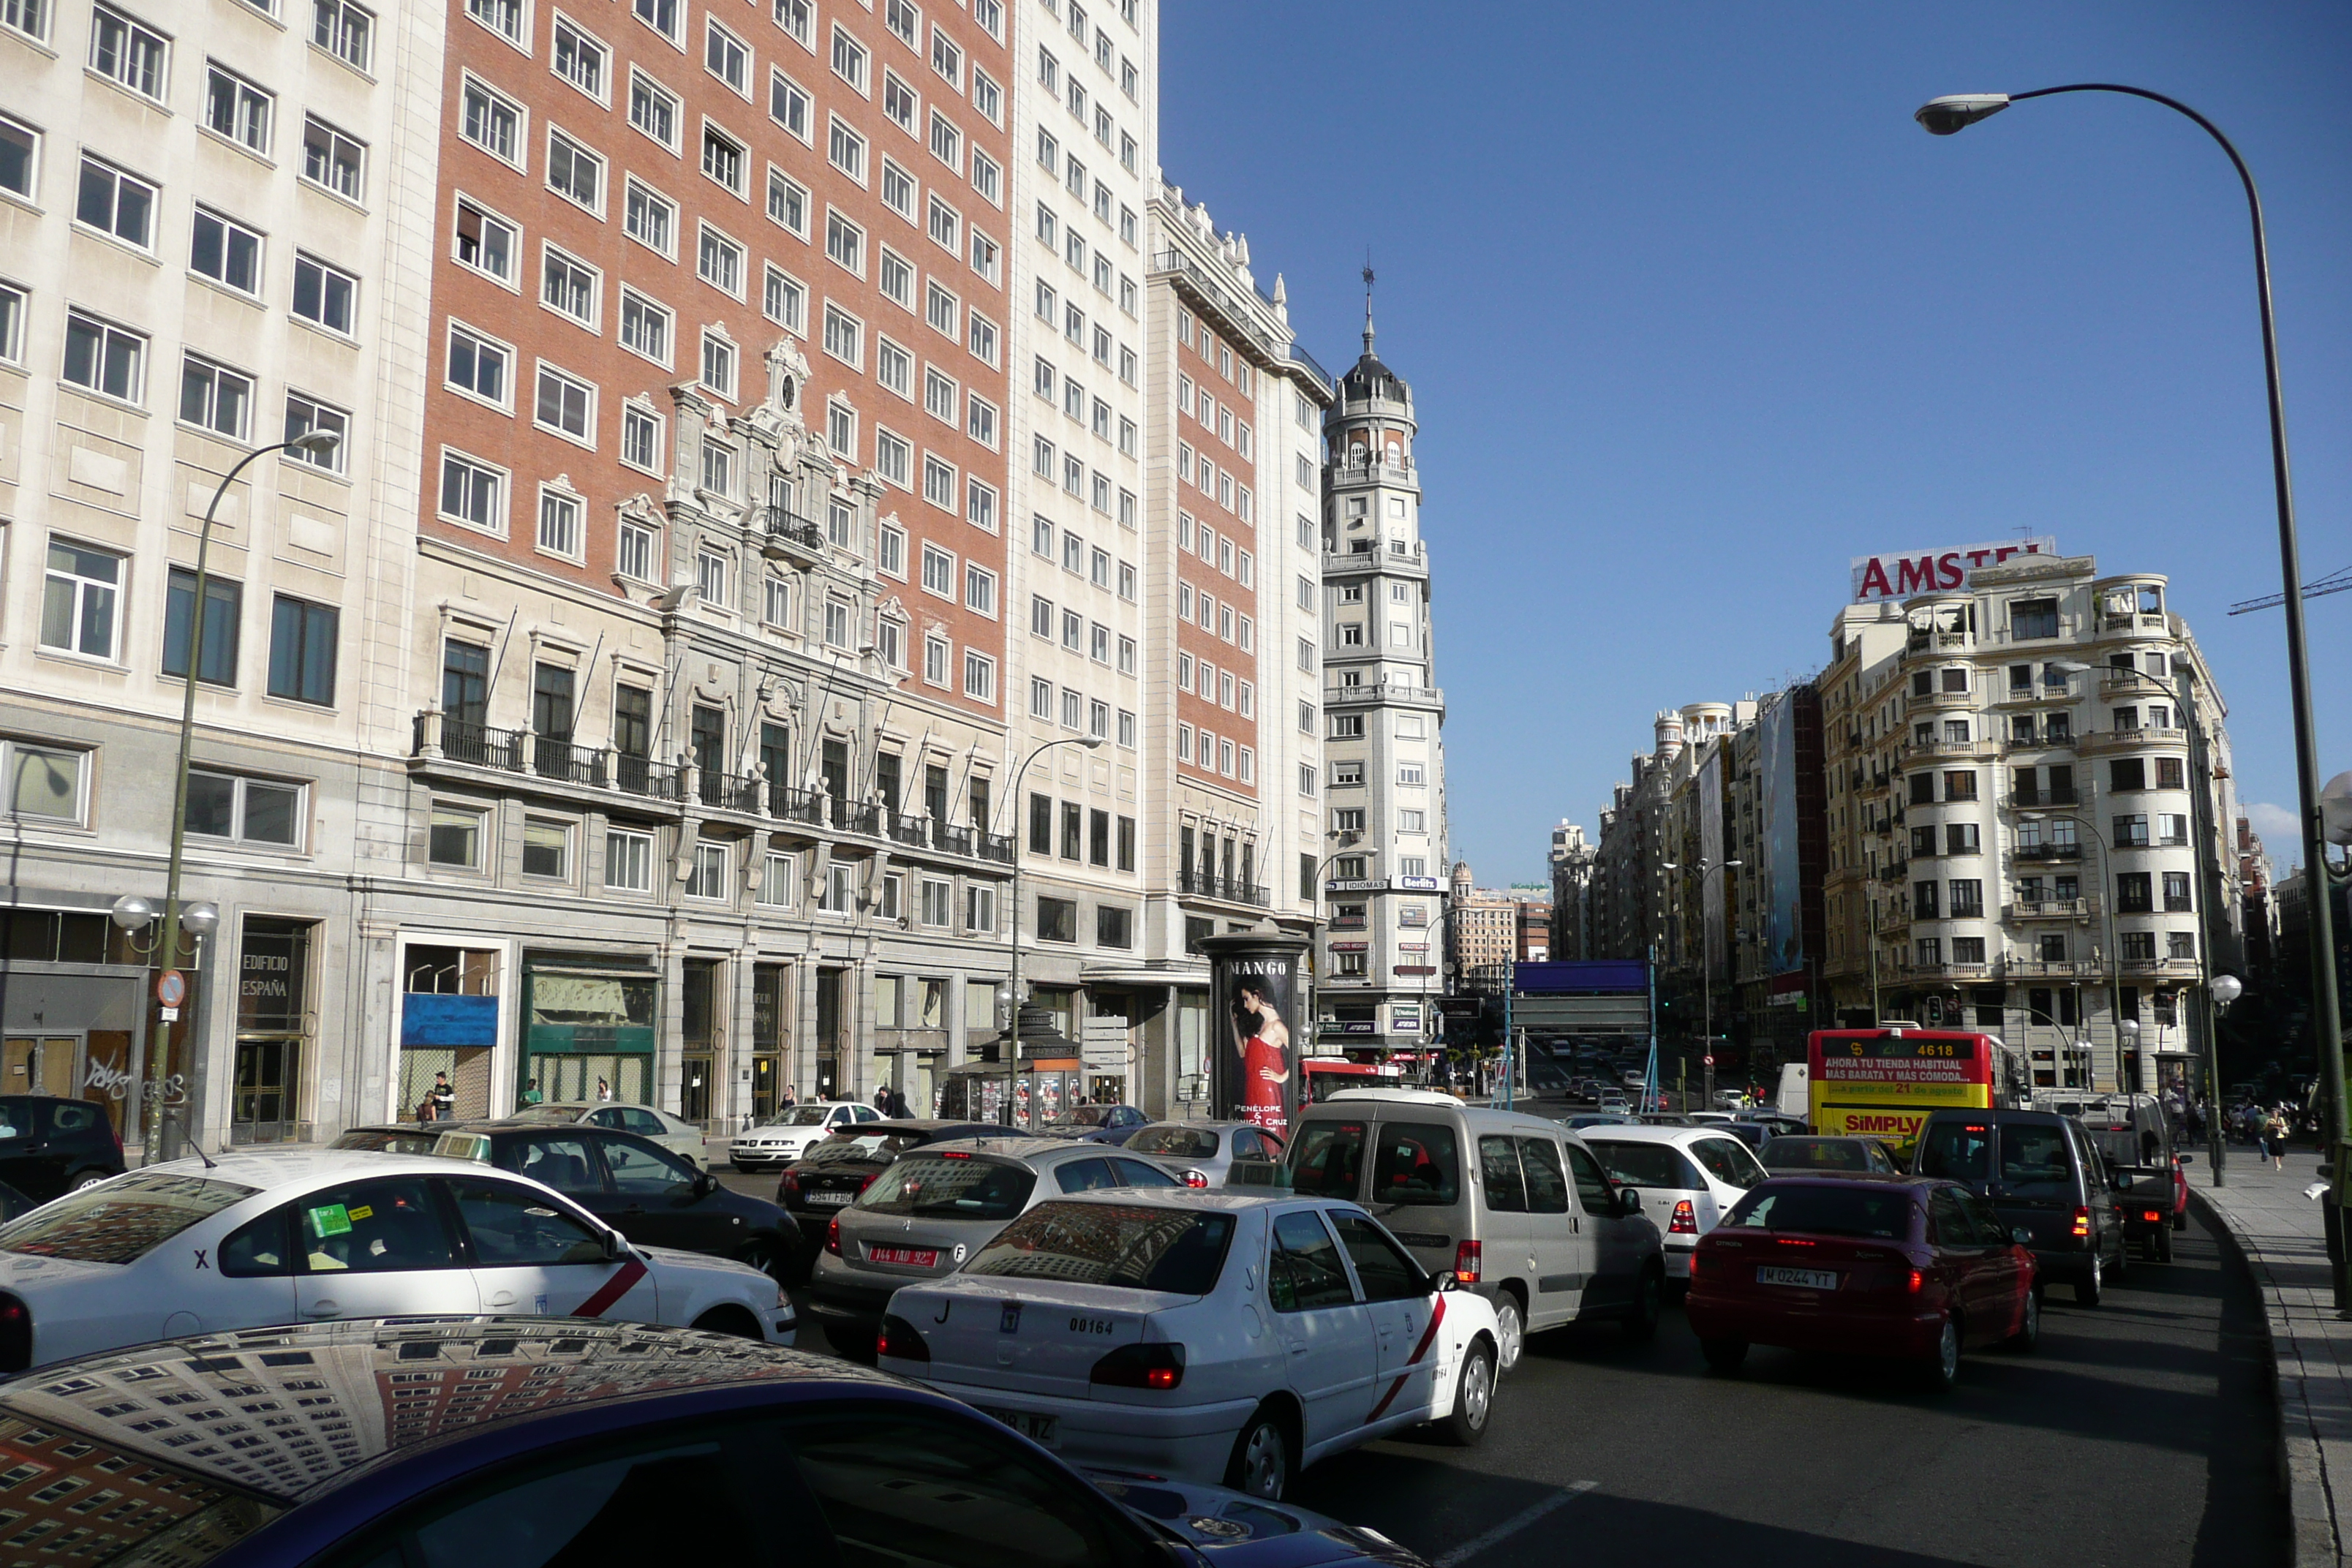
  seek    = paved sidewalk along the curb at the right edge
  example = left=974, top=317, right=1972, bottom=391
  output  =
left=2187, top=1145, right=2352, bottom=1568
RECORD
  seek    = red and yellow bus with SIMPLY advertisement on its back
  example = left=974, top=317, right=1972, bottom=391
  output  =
left=1806, top=1025, right=2025, bottom=1159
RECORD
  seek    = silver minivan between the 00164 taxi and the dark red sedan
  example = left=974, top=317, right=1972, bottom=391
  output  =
left=1282, top=1088, right=1665, bottom=1371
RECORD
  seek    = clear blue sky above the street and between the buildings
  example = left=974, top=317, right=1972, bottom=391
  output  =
left=1159, top=0, right=2352, bottom=886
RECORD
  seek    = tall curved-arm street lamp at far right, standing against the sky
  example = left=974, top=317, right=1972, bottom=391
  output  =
left=1912, top=83, right=2352, bottom=1312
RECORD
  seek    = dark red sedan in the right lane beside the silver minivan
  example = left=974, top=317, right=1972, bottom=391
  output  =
left=1684, top=1175, right=2041, bottom=1390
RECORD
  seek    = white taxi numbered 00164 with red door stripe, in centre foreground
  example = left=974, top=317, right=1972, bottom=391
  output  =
left=875, top=1187, right=1496, bottom=1498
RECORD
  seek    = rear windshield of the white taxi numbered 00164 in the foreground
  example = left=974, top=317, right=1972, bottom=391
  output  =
left=965, top=1204, right=1232, bottom=1295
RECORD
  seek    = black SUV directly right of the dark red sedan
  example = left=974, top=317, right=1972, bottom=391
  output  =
left=1912, top=1109, right=2131, bottom=1307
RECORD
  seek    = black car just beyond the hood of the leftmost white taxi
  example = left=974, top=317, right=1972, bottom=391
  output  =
left=334, top=1121, right=804, bottom=1284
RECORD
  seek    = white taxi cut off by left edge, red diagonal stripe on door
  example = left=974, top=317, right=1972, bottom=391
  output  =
left=0, top=1150, right=795, bottom=1373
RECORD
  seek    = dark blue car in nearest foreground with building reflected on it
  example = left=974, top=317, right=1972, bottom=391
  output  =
left=0, top=1319, right=1416, bottom=1568
